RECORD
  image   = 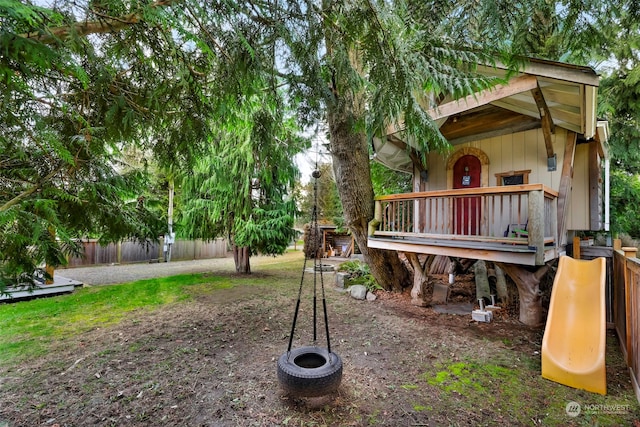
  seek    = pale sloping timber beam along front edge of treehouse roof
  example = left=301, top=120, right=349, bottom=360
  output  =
left=427, top=74, right=538, bottom=120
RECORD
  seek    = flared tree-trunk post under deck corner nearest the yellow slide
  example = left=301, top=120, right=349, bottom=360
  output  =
left=496, top=263, right=549, bottom=326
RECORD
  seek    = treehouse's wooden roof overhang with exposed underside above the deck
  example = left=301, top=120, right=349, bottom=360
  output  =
left=373, top=59, right=608, bottom=172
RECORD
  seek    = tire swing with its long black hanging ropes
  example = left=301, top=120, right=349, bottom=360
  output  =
left=278, top=165, right=342, bottom=397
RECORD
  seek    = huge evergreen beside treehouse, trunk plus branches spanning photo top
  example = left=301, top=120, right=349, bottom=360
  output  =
left=0, top=0, right=637, bottom=289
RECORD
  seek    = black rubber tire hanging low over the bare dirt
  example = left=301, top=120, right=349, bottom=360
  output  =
left=278, top=347, right=342, bottom=397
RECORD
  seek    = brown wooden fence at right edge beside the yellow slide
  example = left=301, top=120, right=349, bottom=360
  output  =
left=613, top=241, right=640, bottom=402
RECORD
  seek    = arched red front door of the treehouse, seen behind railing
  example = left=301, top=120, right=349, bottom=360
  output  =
left=453, top=155, right=482, bottom=235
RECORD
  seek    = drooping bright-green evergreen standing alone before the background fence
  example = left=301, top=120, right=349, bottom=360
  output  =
left=182, top=93, right=306, bottom=274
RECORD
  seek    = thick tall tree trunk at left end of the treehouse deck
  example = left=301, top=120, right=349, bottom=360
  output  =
left=327, top=99, right=411, bottom=291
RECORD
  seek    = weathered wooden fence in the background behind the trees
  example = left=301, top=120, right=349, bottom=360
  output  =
left=67, top=239, right=227, bottom=267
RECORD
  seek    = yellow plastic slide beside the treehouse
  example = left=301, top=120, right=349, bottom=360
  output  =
left=542, top=256, right=607, bottom=394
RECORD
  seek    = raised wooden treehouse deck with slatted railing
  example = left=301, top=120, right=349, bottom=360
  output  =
left=368, top=184, right=564, bottom=265
